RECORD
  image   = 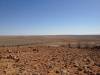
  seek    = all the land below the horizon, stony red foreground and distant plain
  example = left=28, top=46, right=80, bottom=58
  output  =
left=0, top=36, right=100, bottom=75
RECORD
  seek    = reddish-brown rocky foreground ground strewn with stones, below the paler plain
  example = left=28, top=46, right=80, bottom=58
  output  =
left=0, top=46, right=100, bottom=75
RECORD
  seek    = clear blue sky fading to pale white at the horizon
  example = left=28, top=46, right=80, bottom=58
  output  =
left=0, top=0, right=100, bottom=35
